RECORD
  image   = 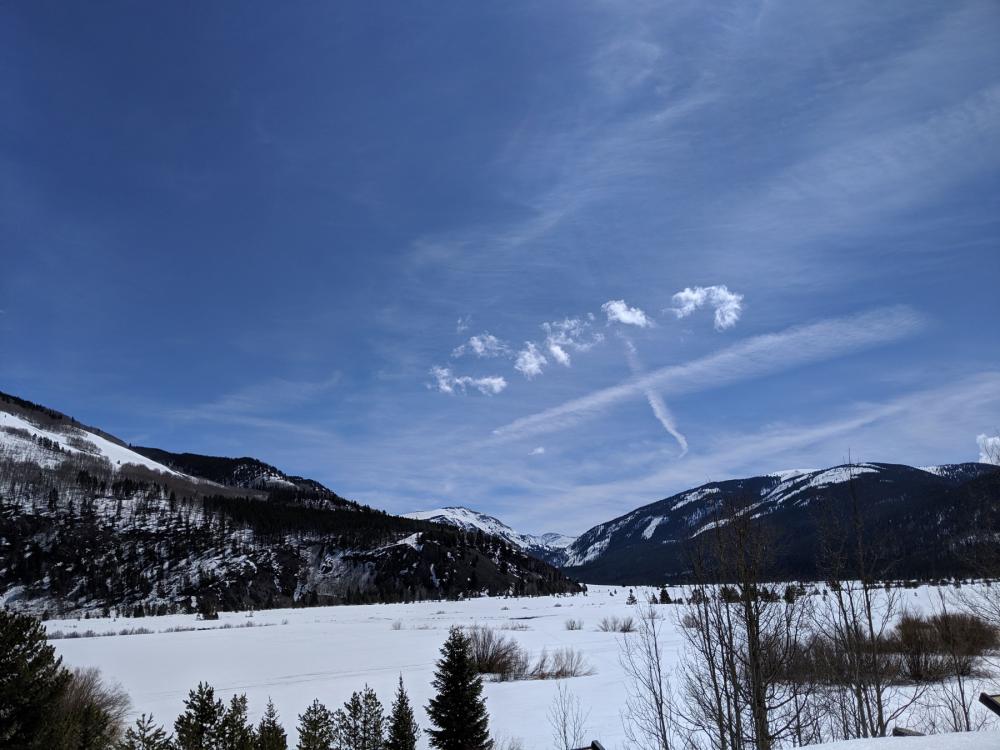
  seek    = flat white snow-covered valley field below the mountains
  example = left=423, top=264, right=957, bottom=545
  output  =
left=47, top=586, right=1000, bottom=750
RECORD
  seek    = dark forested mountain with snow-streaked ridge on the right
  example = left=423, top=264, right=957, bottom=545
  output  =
left=565, top=463, right=1000, bottom=583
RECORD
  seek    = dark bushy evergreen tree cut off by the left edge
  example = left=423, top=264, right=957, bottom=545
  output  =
left=0, top=609, right=70, bottom=748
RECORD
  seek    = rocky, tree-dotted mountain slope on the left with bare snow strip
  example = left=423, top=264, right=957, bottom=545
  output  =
left=0, top=394, right=578, bottom=615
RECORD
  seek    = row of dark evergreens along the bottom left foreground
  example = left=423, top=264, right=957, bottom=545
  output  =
left=0, top=610, right=493, bottom=750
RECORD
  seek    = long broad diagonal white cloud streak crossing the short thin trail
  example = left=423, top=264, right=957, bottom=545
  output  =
left=493, top=306, right=923, bottom=439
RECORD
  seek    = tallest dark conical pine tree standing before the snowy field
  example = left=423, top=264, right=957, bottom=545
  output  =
left=427, top=628, right=493, bottom=750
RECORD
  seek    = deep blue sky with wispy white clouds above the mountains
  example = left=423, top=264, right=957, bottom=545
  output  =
left=0, top=0, right=1000, bottom=533
